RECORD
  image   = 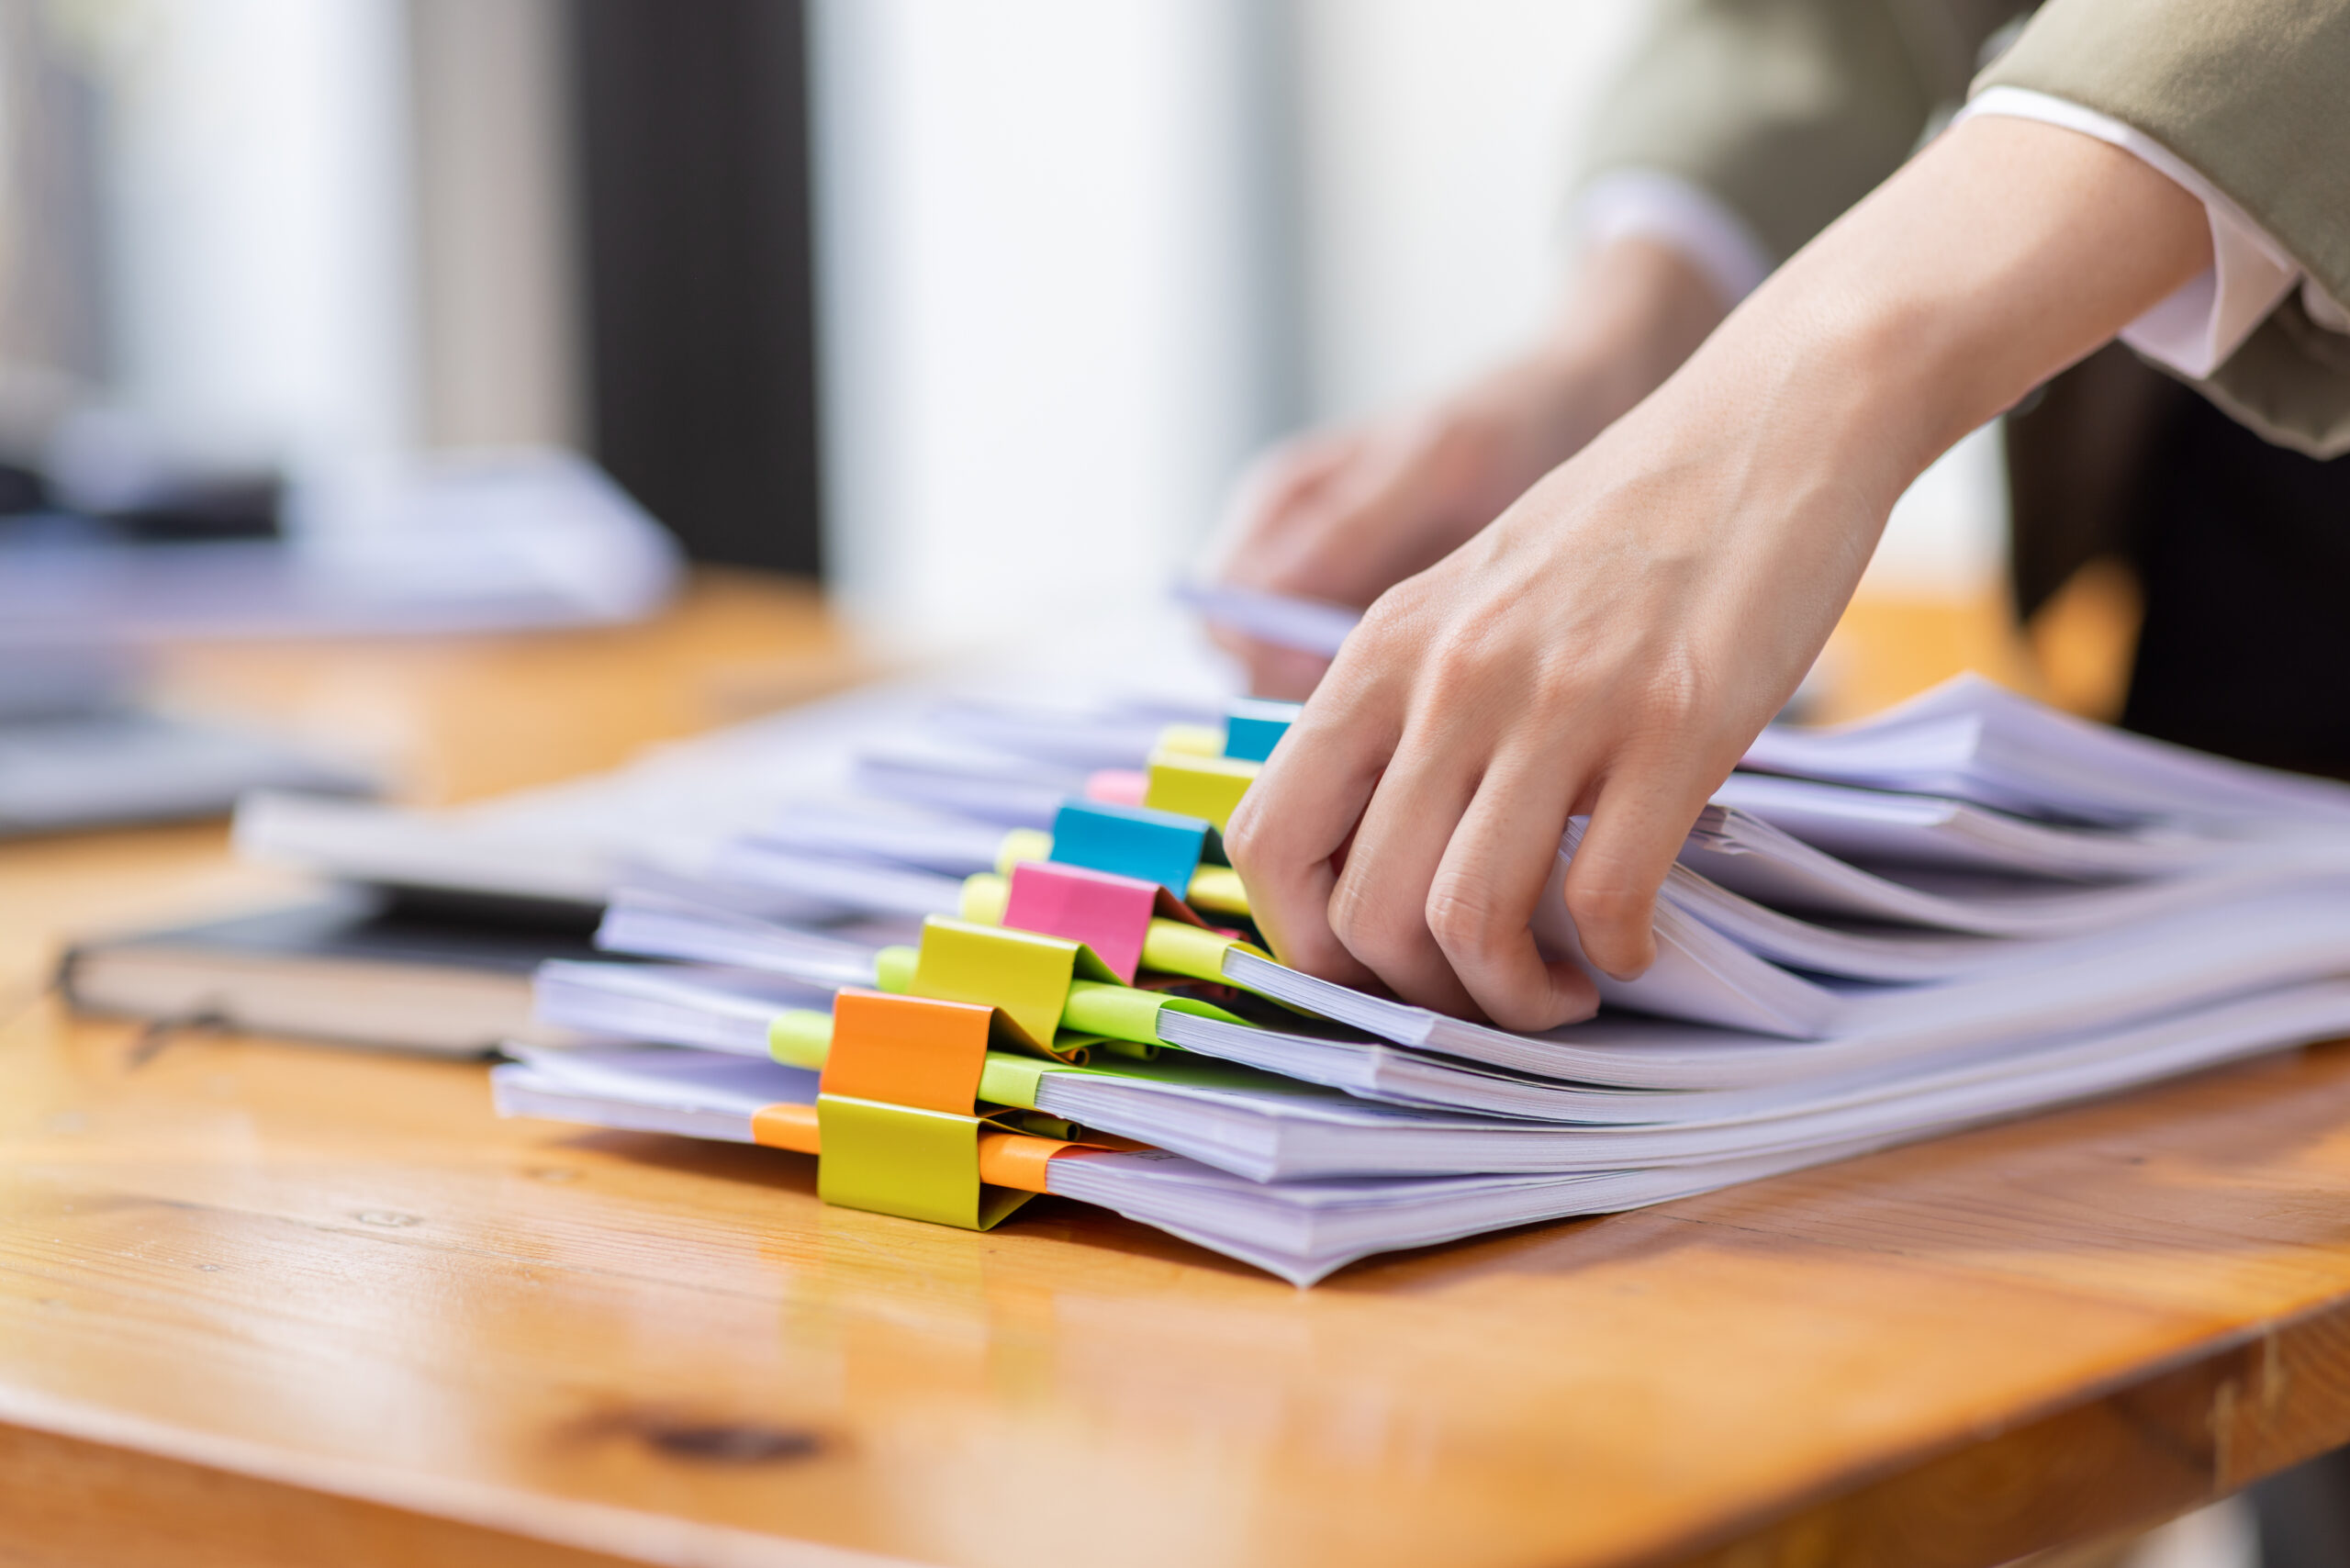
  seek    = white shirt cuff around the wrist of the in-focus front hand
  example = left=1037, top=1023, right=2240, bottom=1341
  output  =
left=1953, top=87, right=2302, bottom=381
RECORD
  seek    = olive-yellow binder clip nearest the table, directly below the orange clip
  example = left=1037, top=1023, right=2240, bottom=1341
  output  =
left=815, top=1095, right=1027, bottom=1229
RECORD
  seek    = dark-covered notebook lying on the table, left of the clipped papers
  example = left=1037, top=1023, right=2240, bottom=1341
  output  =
left=59, top=889, right=611, bottom=1056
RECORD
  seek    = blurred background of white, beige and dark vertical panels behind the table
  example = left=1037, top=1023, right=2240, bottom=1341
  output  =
left=0, top=0, right=2002, bottom=663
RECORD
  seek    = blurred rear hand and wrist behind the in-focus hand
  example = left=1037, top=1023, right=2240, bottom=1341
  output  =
left=1217, top=240, right=1725, bottom=699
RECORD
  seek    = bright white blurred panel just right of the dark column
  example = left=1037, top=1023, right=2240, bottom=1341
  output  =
left=813, top=0, right=1276, bottom=644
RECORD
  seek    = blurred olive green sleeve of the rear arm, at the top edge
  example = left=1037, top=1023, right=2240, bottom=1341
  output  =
left=1586, top=0, right=2011, bottom=261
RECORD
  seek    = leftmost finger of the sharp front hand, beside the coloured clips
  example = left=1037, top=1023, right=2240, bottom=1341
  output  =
left=1225, top=693, right=1396, bottom=985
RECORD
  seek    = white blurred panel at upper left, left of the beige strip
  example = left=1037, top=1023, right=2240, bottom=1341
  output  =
left=99, top=0, right=414, bottom=512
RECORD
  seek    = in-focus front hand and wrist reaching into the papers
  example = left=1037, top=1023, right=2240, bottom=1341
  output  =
left=1225, top=120, right=2209, bottom=1030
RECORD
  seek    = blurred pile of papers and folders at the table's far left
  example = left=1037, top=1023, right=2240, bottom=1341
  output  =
left=0, top=454, right=679, bottom=834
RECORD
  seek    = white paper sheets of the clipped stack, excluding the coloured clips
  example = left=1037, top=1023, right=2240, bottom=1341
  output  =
left=458, top=679, right=2350, bottom=1283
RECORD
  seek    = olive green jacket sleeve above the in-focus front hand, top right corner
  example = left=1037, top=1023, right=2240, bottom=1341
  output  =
left=1976, top=0, right=2350, bottom=456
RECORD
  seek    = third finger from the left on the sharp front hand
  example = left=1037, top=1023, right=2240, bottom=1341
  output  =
left=1424, top=757, right=1600, bottom=1032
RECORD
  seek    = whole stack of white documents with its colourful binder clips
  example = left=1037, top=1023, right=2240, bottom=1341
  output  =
left=458, top=679, right=2350, bottom=1283
